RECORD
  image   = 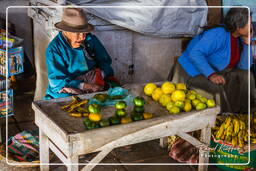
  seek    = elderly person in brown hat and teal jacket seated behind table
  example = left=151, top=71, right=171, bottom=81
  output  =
left=45, top=8, right=118, bottom=99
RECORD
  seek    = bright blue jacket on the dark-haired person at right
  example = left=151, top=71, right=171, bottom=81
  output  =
left=178, top=27, right=252, bottom=77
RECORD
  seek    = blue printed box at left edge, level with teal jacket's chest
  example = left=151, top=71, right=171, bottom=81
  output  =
left=0, top=47, right=24, bottom=77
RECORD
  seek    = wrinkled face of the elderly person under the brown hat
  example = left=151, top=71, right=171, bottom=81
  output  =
left=63, top=32, right=87, bottom=48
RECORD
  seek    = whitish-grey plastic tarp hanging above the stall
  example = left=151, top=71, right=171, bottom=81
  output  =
left=67, top=0, right=208, bottom=37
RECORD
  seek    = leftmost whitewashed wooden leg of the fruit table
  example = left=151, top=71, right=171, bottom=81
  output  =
left=39, top=129, right=49, bottom=171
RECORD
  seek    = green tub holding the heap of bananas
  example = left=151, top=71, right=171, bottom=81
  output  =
left=210, top=140, right=256, bottom=171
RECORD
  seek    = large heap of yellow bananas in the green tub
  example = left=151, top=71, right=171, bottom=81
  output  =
left=213, top=114, right=252, bottom=148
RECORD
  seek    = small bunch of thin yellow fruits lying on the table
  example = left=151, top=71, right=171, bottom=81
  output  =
left=61, top=96, right=89, bottom=117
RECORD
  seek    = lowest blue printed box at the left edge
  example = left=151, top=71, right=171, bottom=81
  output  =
left=0, top=89, right=13, bottom=118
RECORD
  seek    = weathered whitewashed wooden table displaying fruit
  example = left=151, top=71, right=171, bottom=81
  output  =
left=32, top=84, right=220, bottom=171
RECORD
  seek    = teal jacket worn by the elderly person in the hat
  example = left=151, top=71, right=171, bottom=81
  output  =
left=44, top=32, right=114, bottom=99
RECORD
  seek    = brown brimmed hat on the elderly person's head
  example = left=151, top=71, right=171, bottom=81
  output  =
left=54, top=8, right=94, bottom=33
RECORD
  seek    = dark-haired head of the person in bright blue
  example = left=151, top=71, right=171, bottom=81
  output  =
left=224, top=7, right=252, bottom=36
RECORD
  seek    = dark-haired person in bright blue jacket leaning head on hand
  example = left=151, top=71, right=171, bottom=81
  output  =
left=176, top=8, right=255, bottom=112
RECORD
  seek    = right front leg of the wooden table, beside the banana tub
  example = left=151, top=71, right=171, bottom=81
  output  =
left=198, top=125, right=211, bottom=171
